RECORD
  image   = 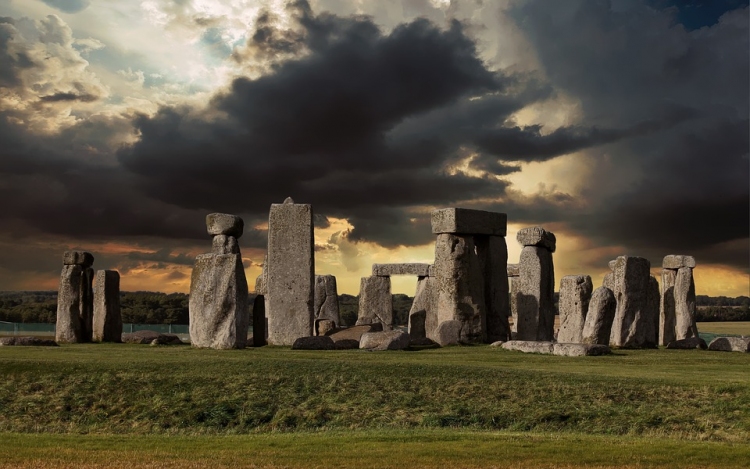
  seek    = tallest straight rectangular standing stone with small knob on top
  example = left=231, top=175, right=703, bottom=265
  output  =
left=266, top=202, right=315, bottom=345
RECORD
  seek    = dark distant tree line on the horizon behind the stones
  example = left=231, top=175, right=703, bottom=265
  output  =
left=0, top=291, right=750, bottom=326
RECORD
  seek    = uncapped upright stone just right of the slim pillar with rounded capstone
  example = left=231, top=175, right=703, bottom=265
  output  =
left=557, top=275, right=594, bottom=344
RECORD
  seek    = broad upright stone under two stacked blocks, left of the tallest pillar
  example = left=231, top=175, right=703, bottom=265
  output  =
left=189, top=254, right=250, bottom=349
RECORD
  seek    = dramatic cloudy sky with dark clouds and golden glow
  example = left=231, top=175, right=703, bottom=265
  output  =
left=0, top=0, right=750, bottom=296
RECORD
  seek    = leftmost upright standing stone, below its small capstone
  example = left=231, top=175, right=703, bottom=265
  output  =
left=55, top=264, right=84, bottom=343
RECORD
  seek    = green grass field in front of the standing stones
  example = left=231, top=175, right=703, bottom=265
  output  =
left=0, top=344, right=750, bottom=468
